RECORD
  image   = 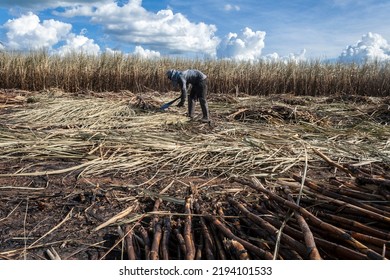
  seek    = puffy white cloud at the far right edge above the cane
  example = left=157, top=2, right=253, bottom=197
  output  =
left=339, top=32, right=390, bottom=63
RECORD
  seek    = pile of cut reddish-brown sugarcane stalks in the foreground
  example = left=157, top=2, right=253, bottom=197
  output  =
left=116, top=171, right=390, bottom=260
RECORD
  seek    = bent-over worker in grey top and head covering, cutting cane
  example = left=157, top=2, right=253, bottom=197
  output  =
left=167, top=69, right=210, bottom=123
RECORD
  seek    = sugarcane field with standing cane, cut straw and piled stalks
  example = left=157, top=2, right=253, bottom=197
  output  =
left=0, top=52, right=390, bottom=260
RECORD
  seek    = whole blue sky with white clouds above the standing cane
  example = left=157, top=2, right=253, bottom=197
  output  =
left=0, top=0, right=390, bottom=60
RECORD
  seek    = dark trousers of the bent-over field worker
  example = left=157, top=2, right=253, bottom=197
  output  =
left=188, top=79, right=209, bottom=119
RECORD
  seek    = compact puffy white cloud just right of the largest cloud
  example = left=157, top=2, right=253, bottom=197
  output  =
left=217, top=27, right=266, bottom=61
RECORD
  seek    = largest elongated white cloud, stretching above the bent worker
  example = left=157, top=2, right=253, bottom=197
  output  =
left=57, top=0, right=220, bottom=57
